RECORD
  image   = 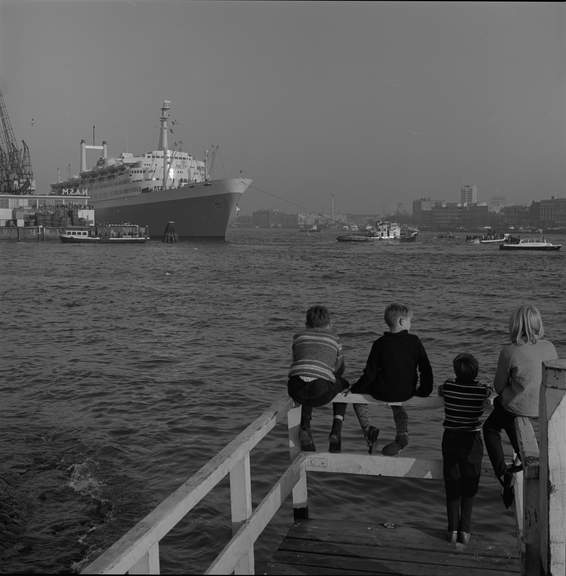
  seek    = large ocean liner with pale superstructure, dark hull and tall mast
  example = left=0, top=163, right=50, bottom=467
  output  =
left=51, top=100, right=252, bottom=239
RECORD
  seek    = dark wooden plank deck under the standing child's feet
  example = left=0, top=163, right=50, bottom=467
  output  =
left=266, top=518, right=521, bottom=576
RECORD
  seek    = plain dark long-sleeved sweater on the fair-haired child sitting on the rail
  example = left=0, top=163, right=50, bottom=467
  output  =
left=352, top=330, right=433, bottom=402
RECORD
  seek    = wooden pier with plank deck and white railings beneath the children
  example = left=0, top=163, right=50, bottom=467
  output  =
left=82, top=360, right=566, bottom=576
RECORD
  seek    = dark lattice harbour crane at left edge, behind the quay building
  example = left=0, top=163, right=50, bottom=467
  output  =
left=0, top=91, right=35, bottom=194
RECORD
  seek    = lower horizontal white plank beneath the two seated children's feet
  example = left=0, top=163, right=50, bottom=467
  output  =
left=306, top=452, right=493, bottom=480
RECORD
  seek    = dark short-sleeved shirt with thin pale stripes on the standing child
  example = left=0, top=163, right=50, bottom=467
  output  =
left=439, top=380, right=491, bottom=432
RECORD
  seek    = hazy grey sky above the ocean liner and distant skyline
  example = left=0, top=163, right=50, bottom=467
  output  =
left=0, top=0, right=566, bottom=213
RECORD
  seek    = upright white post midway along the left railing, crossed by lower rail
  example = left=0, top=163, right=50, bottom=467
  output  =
left=230, top=452, right=255, bottom=574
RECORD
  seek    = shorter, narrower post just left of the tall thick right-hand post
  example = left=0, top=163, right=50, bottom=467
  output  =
left=515, top=416, right=541, bottom=576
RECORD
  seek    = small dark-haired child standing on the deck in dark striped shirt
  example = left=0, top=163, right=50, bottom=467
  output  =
left=438, top=354, right=491, bottom=544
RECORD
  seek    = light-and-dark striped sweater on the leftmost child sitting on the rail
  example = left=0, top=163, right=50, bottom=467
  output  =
left=289, top=328, right=344, bottom=382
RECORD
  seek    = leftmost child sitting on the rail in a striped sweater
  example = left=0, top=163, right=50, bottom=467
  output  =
left=287, top=306, right=349, bottom=451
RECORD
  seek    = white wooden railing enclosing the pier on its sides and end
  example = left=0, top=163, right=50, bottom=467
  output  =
left=82, top=360, right=566, bottom=576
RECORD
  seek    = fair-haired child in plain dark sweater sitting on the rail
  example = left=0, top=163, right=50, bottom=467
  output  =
left=335, top=304, right=433, bottom=456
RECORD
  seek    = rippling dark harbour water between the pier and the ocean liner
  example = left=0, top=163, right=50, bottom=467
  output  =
left=0, top=230, right=566, bottom=573
